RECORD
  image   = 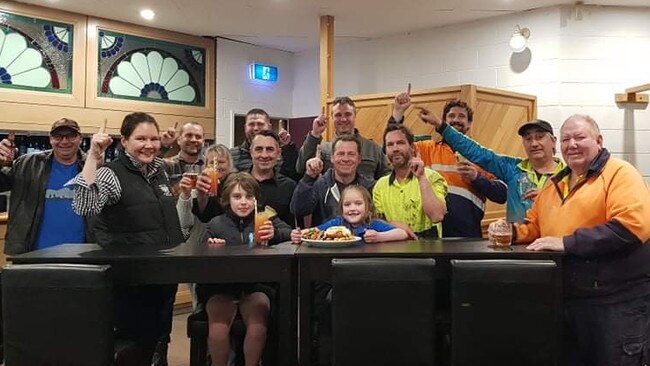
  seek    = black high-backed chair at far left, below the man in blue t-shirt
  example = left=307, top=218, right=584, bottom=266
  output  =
left=2, top=264, right=138, bottom=366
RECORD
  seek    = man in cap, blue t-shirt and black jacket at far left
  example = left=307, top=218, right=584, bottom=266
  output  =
left=0, top=118, right=90, bottom=255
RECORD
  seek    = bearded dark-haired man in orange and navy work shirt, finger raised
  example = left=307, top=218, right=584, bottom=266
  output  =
left=388, top=92, right=508, bottom=238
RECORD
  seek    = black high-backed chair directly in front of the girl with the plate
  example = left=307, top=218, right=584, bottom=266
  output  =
left=332, top=258, right=436, bottom=366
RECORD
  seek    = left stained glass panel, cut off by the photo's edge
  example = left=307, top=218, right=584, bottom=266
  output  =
left=0, top=11, right=74, bottom=94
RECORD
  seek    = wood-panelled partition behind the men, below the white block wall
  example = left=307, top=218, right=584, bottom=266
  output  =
left=328, top=85, right=537, bottom=228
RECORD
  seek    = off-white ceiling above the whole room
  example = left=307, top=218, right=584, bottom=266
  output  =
left=15, top=0, right=650, bottom=52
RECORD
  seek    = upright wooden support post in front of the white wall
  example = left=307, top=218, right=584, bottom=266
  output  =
left=319, top=15, right=334, bottom=139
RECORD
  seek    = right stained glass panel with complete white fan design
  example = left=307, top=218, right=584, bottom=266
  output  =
left=97, top=29, right=205, bottom=106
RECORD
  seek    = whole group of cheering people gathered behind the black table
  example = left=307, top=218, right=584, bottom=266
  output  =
left=0, top=87, right=650, bottom=365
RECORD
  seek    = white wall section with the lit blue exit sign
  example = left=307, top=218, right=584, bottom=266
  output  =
left=216, top=39, right=294, bottom=146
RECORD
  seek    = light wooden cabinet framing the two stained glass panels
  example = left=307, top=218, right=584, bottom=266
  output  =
left=0, top=0, right=216, bottom=139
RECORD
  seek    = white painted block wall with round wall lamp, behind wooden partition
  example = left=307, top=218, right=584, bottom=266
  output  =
left=293, top=6, right=650, bottom=179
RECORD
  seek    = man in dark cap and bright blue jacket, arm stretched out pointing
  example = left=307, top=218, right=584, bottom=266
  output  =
left=420, top=109, right=565, bottom=222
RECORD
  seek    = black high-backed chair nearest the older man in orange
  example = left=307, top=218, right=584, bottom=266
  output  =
left=451, top=260, right=561, bottom=366
